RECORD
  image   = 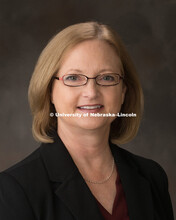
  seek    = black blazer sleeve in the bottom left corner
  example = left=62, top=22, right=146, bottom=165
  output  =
left=0, top=172, right=36, bottom=220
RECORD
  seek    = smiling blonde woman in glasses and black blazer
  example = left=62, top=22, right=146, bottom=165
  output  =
left=0, top=22, right=173, bottom=220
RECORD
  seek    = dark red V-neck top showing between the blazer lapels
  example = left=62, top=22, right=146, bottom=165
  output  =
left=97, top=168, right=129, bottom=220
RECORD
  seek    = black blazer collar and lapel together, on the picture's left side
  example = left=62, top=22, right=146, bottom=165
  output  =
left=41, top=131, right=103, bottom=220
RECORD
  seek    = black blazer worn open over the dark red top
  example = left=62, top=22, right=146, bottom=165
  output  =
left=0, top=135, right=174, bottom=220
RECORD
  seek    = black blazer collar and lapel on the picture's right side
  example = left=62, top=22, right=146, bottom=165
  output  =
left=110, top=143, right=154, bottom=220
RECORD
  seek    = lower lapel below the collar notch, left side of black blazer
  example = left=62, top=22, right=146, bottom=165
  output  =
left=55, top=171, right=103, bottom=220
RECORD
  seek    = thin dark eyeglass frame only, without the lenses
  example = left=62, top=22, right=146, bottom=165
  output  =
left=53, top=73, right=124, bottom=87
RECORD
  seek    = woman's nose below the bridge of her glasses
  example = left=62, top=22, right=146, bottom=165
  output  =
left=82, top=79, right=99, bottom=99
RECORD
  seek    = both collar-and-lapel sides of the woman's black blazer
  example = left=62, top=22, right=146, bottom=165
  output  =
left=41, top=133, right=153, bottom=220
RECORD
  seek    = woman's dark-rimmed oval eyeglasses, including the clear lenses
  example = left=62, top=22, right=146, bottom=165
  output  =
left=53, top=73, right=124, bottom=87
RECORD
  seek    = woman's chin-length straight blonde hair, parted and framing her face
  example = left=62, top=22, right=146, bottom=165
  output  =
left=28, top=22, right=143, bottom=144
